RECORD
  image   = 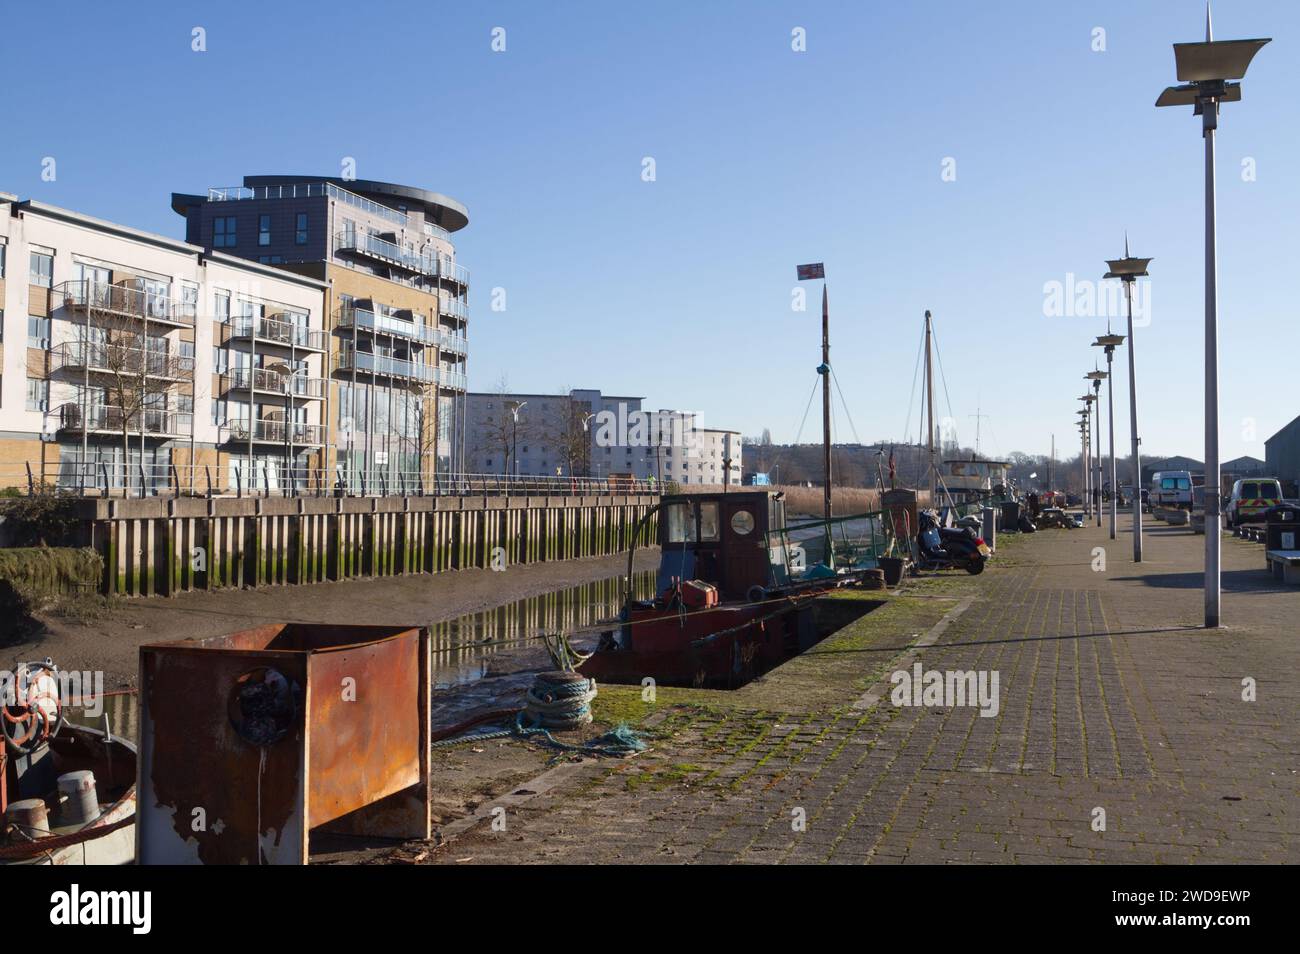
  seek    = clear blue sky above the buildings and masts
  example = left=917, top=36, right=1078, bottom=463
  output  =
left=0, top=0, right=1300, bottom=459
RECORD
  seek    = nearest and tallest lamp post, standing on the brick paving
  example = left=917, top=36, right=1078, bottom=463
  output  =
left=1156, top=6, right=1270, bottom=629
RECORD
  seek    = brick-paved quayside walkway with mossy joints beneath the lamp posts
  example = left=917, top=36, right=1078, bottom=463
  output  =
left=433, top=519, right=1300, bottom=863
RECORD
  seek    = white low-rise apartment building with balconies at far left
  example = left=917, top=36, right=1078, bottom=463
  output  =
left=0, top=194, right=328, bottom=493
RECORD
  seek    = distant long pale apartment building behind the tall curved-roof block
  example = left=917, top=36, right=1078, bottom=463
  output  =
left=465, top=389, right=741, bottom=486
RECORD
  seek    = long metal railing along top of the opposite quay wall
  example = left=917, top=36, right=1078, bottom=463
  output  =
left=0, top=455, right=659, bottom=496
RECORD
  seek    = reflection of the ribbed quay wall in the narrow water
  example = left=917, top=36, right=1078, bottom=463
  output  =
left=430, top=569, right=657, bottom=689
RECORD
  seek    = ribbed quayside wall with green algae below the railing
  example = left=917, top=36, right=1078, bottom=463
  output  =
left=81, top=495, right=658, bottom=597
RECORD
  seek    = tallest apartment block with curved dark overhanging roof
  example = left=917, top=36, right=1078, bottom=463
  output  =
left=172, top=175, right=469, bottom=493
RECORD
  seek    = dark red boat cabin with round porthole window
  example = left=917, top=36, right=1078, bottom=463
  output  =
left=658, top=490, right=789, bottom=600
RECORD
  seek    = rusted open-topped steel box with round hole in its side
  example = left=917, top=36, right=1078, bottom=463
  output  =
left=135, top=623, right=430, bottom=864
